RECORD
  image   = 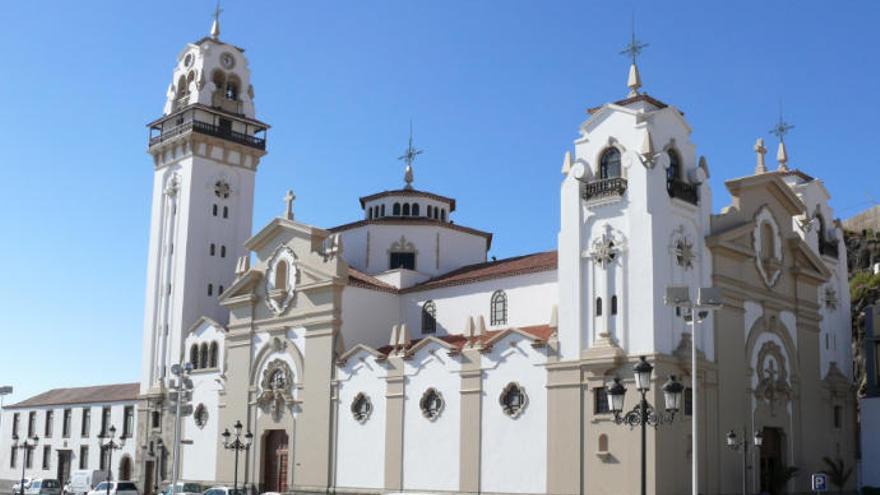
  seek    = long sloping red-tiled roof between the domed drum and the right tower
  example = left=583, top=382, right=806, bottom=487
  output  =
left=402, top=251, right=557, bottom=292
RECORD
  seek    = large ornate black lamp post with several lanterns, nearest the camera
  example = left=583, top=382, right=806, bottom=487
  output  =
left=608, top=356, right=684, bottom=495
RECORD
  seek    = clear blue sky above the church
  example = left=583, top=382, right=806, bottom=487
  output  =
left=0, top=0, right=880, bottom=403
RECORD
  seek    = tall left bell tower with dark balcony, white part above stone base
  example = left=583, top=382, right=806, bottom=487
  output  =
left=141, top=14, right=269, bottom=394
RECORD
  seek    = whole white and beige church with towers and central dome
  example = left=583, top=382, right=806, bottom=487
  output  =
left=0, top=12, right=856, bottom=494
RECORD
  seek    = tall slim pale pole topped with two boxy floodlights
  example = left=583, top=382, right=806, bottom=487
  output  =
left=664, top=286, right=721, bottom=495
